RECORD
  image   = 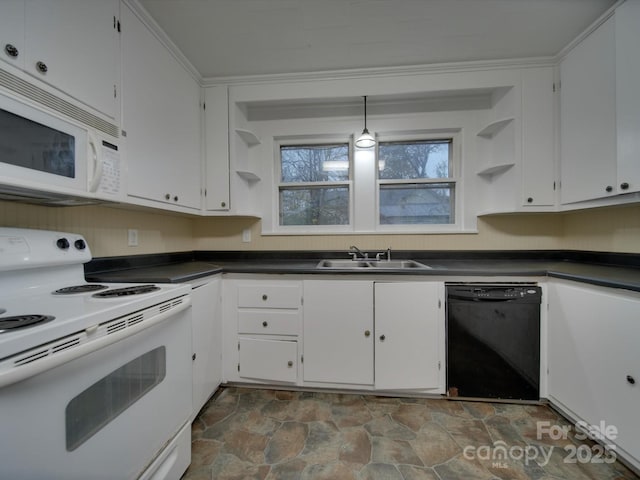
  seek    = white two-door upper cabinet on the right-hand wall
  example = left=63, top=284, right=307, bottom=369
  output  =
left=560, top=2, right=640, bottom=204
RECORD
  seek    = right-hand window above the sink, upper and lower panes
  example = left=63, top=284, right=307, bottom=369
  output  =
left=378, top=139, right=455, bottom=225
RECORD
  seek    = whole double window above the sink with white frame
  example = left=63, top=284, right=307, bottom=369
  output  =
left=272, top=128, right=468, bottom=235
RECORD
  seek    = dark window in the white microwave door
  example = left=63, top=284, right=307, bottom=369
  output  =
left=0, top=110, right=76, bottom=178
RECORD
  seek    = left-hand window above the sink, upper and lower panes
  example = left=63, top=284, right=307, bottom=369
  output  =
left=278, top=143, right=351, bottom=226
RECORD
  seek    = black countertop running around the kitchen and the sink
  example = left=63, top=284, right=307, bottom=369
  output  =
left=85, top=251, right=640, bottom=292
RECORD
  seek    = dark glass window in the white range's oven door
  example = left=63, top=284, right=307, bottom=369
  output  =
left=65, top=347, right=167, bottom=452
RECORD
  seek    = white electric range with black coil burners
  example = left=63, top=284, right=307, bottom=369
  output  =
left=0, top=228, right=192, bottom=479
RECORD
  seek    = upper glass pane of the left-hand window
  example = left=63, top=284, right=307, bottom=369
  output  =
left=280, top=144, right=349, bottom=182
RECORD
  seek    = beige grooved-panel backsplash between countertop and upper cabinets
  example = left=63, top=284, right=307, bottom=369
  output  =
left=0, top=202, right=640, bottom=257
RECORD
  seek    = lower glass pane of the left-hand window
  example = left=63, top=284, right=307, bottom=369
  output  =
left=280, top=187, right=349, bottom=225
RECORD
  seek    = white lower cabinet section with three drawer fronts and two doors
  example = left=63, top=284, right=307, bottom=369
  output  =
left=223, top=276, right=445, bottom=394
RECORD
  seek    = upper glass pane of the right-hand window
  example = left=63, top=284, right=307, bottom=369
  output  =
left=378, top=140, right=451, bottom=180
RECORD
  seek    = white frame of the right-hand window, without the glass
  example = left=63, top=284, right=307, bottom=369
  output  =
left=375, top=130, right=462, bottom=233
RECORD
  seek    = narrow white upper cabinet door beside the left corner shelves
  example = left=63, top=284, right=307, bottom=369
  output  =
left=204, top=86, right=230, bottom=211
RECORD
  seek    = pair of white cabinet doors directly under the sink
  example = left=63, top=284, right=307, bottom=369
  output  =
left=303, top=280, right=445, bottom=393
